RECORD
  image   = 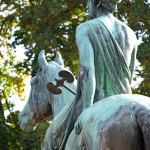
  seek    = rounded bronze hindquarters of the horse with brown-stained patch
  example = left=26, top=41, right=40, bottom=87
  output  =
left=66, top=94, right=150, bottom=150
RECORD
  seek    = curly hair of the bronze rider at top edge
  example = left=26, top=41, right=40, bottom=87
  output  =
left=93, top=0, right=122, bottom=13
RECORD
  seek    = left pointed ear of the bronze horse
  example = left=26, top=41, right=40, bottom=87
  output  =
left=38, top=50, right=48, bottom=69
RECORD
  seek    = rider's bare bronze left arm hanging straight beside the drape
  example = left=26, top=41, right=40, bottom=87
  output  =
left=76, top=23, right=96, bottom=108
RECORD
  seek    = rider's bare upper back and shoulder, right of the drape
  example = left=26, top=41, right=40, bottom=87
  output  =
left=90, top=15, right=137, bottom=67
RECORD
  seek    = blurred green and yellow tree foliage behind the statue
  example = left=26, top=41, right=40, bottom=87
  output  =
left=0, top=0, right=150, bottom=150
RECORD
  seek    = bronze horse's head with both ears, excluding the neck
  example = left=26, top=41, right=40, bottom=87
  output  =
left=19, top=51, right=68, bottom=132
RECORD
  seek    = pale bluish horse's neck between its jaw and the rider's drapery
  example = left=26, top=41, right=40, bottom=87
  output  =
left=52, top=82, right=76, bottom=117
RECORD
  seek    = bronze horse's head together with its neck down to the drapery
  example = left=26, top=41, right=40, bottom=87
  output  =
left=19, top=51, right=77, bottom=132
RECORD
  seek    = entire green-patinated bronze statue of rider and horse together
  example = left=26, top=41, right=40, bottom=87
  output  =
left=19, top=0, right=150, bottom=150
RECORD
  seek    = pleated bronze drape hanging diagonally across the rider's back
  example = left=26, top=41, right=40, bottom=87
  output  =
left=88, top=18, right=131, bottom=102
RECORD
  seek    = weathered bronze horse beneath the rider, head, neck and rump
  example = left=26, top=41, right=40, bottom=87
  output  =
left=19, top=51, right=150, bottom=150
